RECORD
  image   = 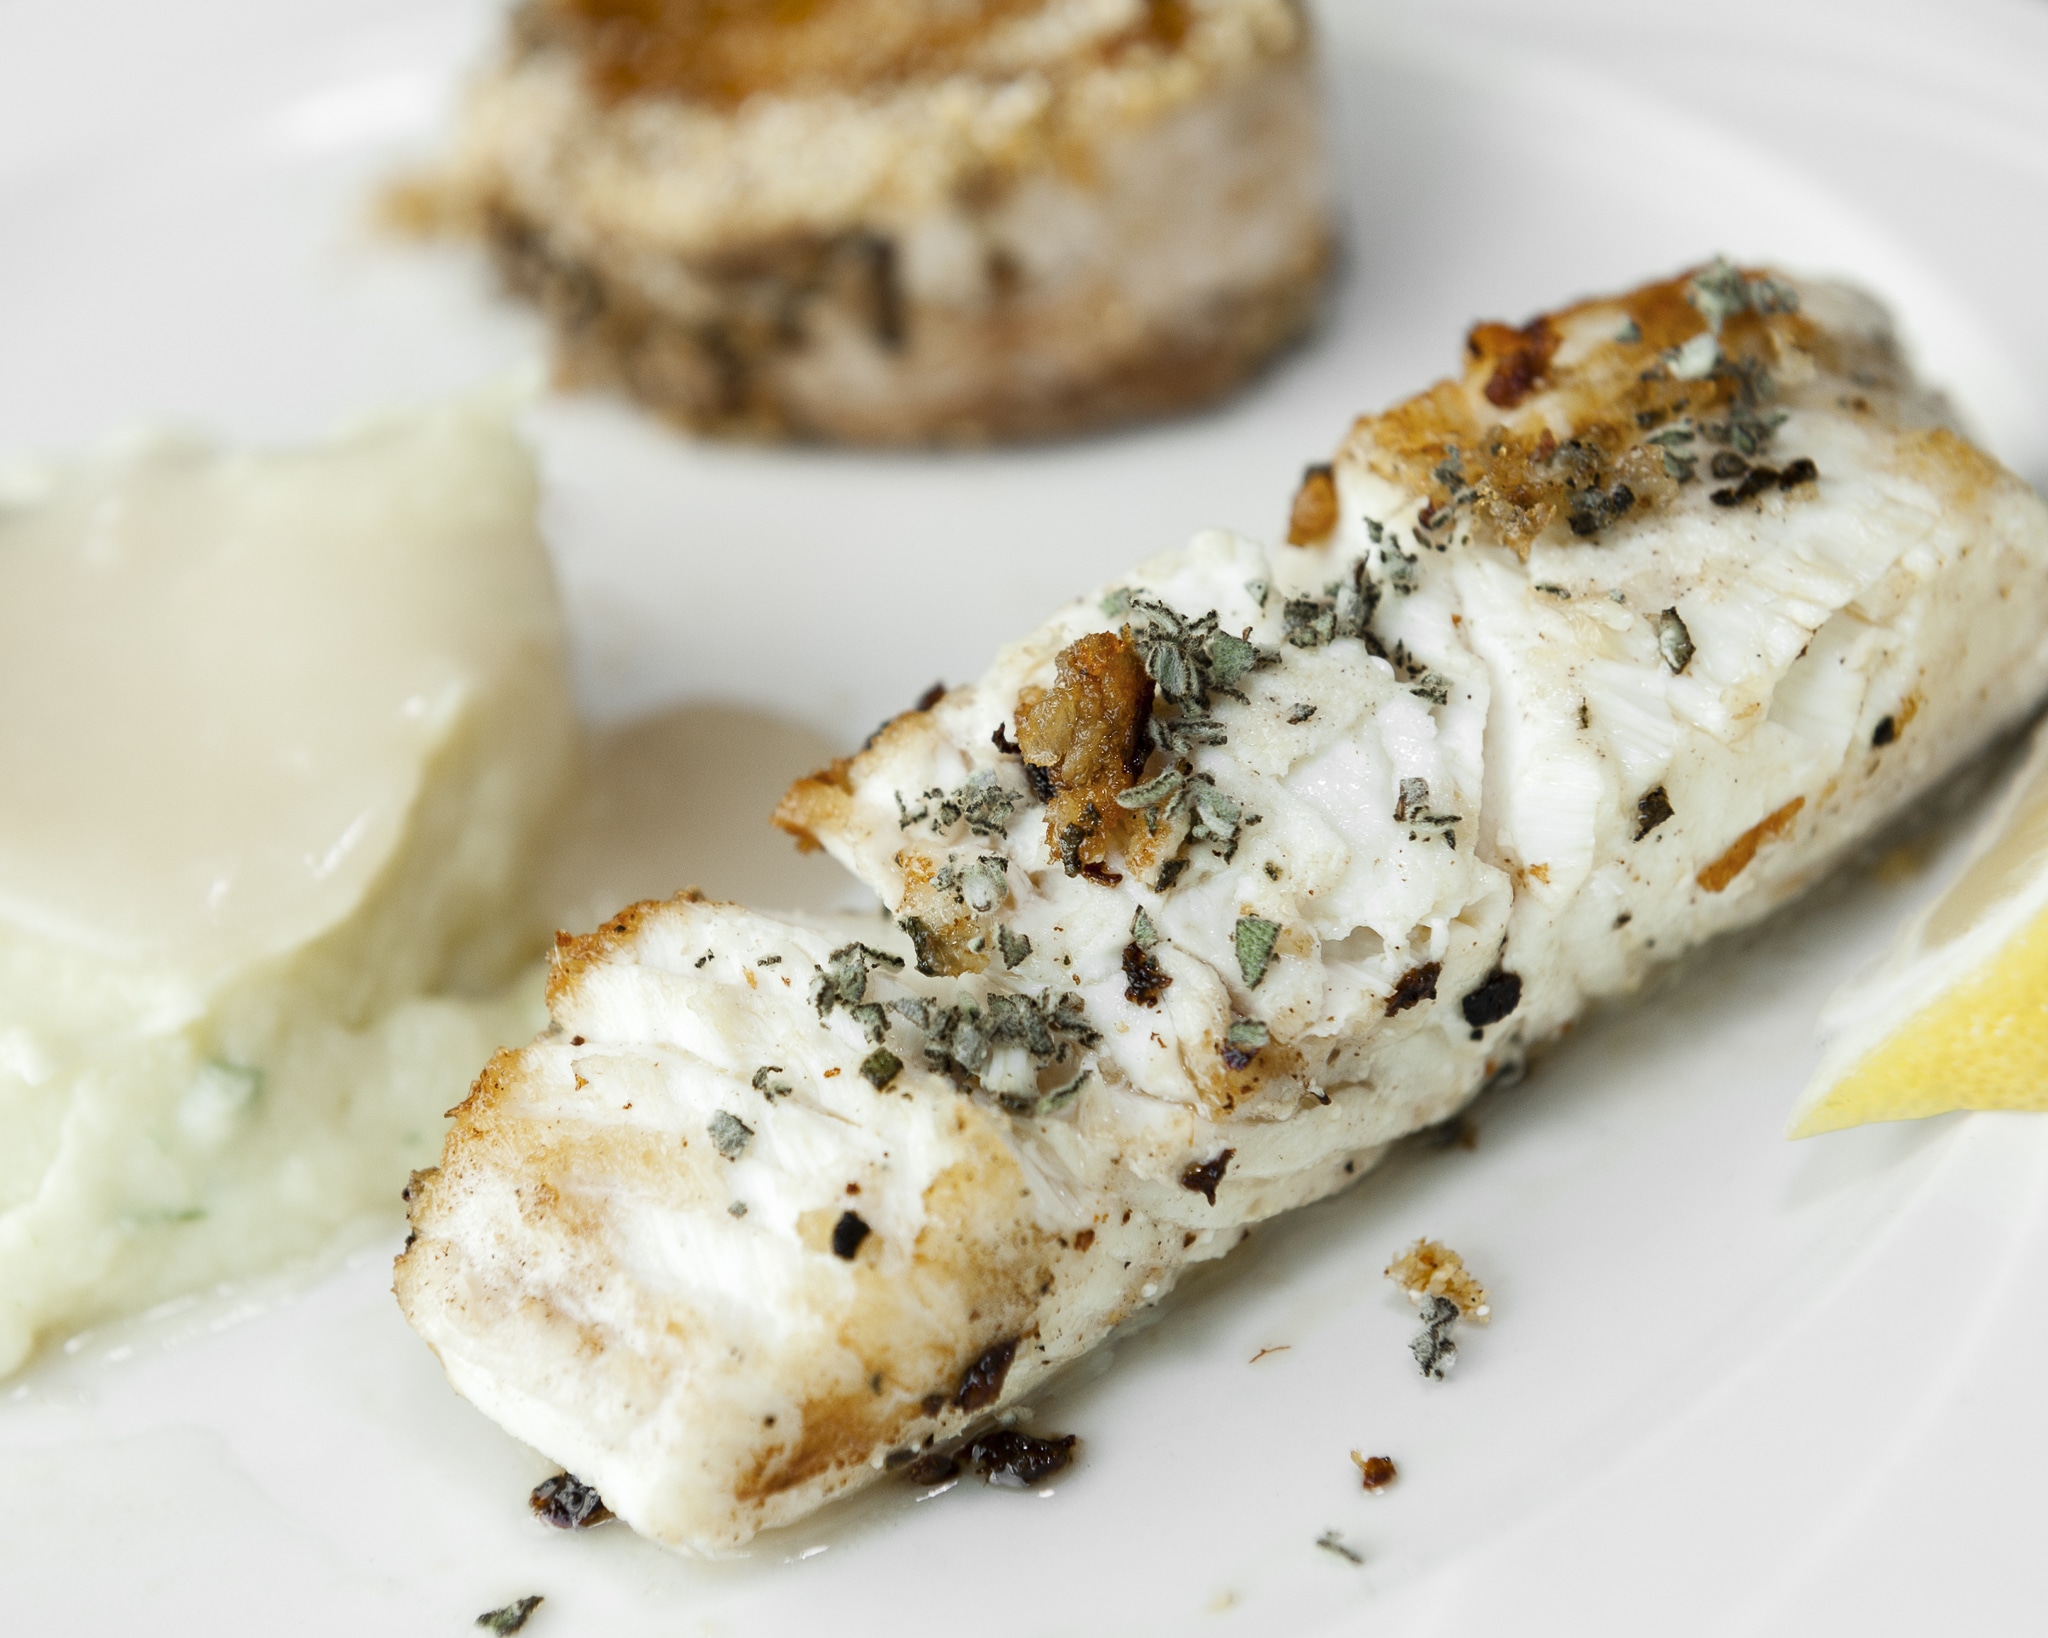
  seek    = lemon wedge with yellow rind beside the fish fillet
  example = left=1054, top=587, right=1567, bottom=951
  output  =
left=1788, top=729, right=2048, bottom=1138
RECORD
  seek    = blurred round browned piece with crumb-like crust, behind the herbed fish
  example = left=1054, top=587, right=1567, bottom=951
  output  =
left=415, top=0, right=1331, bottom=444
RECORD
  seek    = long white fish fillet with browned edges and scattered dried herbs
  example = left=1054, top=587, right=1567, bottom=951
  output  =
left=397, top=264, right=2048, bottom=1552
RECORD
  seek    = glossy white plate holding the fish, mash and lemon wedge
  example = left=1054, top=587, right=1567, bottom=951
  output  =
left=0, top=0, right=2048, bottom=1638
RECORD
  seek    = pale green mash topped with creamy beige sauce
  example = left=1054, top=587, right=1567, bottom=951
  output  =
left=0, top=403, right=573, bottom=1372
